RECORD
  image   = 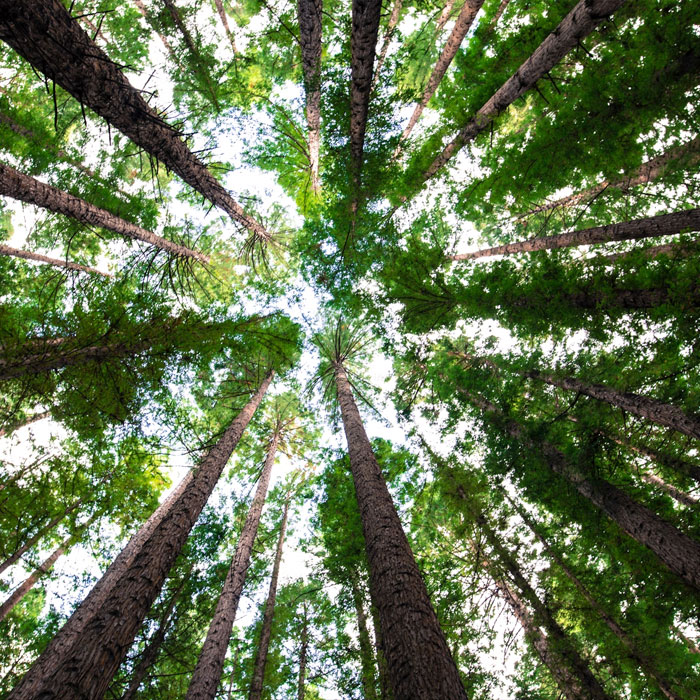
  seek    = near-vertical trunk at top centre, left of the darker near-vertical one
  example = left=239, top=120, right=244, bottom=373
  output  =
left=297, top=0, right=323, bottom=194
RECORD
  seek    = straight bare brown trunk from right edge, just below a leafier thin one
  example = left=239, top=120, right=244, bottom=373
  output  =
left=448, top=209, right=700, bottom=260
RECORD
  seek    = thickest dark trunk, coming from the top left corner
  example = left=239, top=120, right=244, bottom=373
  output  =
left=0, top=0, right=267, bottom=235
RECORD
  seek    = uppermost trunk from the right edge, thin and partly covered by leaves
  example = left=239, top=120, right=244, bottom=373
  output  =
left=518, top=138, right=700, bottom=220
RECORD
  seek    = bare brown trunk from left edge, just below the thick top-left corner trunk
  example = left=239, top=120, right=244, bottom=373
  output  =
left=0, top=163, right=209, bottom=262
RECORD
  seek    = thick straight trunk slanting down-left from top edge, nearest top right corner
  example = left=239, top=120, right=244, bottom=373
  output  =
left=423, top=0, right=625, bottom=181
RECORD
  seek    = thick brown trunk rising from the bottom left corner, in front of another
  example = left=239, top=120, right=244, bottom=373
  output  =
left=8, top=373, right=272, bottom=700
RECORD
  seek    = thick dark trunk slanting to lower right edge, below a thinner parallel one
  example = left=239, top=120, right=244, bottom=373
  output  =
left=458, top=388, right=700, bottom=590
